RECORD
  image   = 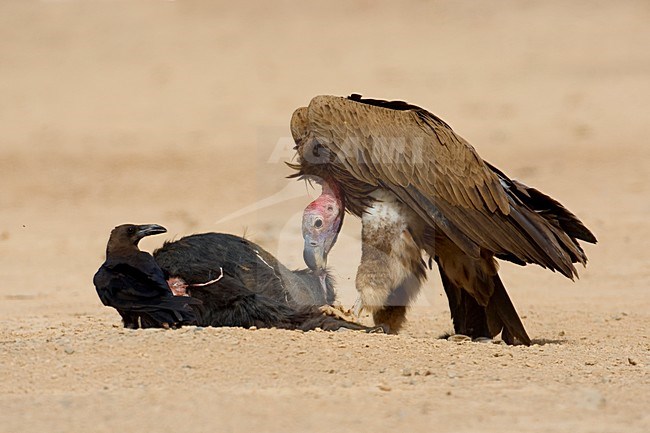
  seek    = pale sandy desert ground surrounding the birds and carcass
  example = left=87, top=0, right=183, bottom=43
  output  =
left=0, top=1, right=650, bottom=433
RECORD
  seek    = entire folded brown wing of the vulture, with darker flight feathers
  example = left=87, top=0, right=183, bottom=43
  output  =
left=291, top=96, right=586, bottom=278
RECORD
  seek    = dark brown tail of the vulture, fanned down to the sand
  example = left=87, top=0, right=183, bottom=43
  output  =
left=436, top=238, right=530, bottom=345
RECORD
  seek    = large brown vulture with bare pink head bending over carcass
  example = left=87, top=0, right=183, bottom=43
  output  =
left=290, top=95, right=596, bottom=344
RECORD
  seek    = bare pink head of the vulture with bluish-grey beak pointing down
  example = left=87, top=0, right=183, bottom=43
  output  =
left=302, top=181, right=345, bottom=272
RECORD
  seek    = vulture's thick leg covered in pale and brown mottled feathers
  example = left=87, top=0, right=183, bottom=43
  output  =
left=356, top=197, right=426, bottom=333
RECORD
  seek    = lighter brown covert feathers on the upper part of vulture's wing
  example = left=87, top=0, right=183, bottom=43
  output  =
left=307, top=96, right=510, bottom=215
